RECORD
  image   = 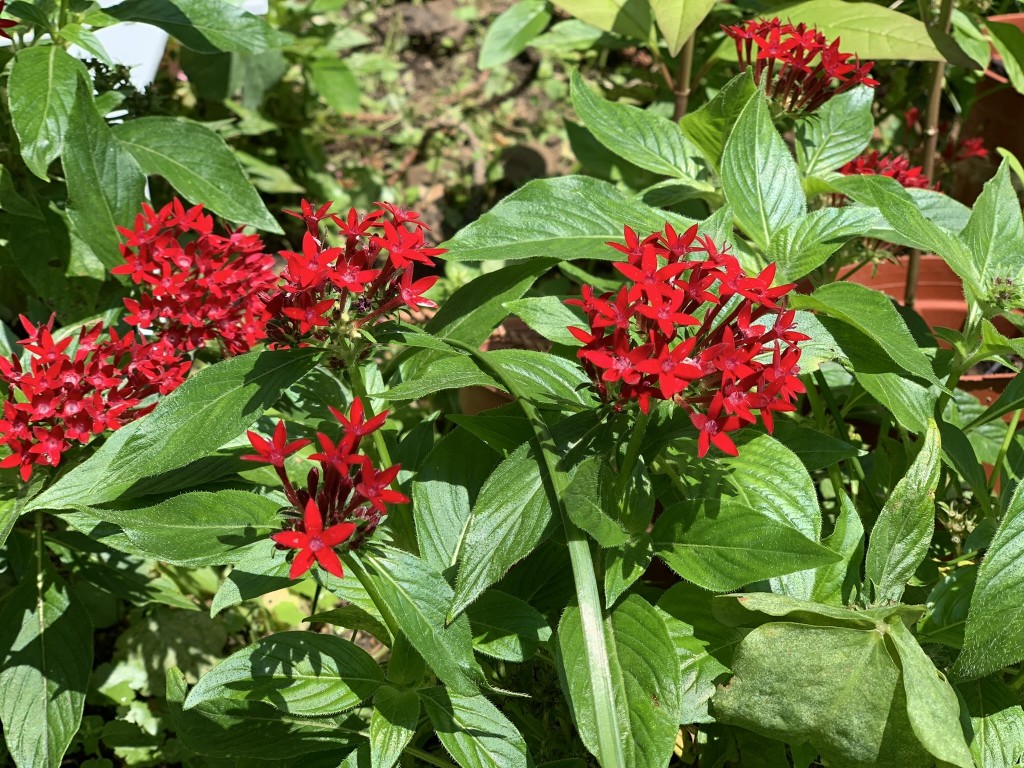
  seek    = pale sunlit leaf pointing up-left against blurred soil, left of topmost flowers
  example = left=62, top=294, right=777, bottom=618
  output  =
left=572, top=71, right=699, bottom=178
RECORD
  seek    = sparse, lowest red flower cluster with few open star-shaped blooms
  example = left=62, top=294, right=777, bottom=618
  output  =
left=242, top=399, right=409, bottom=579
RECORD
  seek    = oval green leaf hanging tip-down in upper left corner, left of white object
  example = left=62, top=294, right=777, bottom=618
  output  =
left=7, top=45, right=88, bottom=181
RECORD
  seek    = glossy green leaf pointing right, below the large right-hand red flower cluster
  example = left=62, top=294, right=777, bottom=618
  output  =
left=651, top=497, right=842, bottom=592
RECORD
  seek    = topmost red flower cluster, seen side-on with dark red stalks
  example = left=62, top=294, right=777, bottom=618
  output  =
left=722, top=18, right=879, bottom=113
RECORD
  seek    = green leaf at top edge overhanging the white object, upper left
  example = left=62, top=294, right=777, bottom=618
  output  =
left=105, top=0, right=289, bottom=54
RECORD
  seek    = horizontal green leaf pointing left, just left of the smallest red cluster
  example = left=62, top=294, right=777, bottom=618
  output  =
left=80, top=490, right=281, bottom=567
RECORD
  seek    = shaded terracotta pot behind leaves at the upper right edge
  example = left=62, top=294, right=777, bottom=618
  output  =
left=952, top=13, right=1024, bottom=205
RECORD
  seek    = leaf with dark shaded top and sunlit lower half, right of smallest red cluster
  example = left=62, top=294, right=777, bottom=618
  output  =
left=412, top=429, right=498, bottom=573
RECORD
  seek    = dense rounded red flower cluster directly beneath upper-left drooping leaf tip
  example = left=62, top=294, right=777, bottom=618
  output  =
left=112, top=199, right=278, bottom=355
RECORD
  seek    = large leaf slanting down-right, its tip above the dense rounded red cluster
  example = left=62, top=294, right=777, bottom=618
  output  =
left=114, top=116, right=282, bottom=233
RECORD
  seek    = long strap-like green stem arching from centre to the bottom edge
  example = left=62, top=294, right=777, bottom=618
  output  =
left=445, top=339, right=626, bottom=768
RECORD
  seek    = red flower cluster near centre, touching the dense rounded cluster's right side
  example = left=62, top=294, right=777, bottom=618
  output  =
left=262, top=201, right=444, bottom=352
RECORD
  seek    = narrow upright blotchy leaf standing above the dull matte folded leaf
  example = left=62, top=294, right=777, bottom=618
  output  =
left=864, top=421, right=942, bottom=602
